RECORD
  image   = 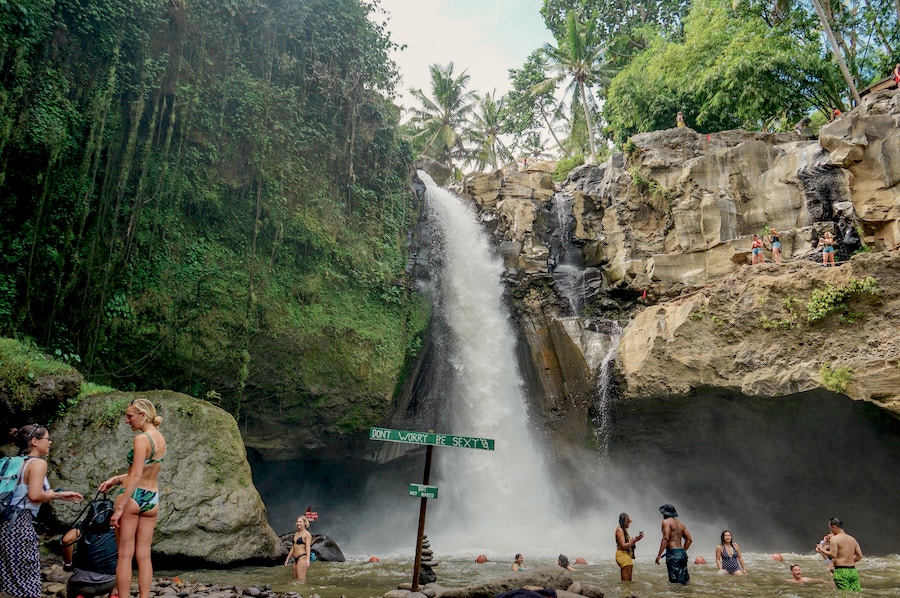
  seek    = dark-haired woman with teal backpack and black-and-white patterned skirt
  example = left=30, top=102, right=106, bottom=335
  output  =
left=0, top=424, right=83, bottom=598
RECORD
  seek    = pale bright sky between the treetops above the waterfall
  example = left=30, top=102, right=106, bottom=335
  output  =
left=380, top=0, right=554, bottom=116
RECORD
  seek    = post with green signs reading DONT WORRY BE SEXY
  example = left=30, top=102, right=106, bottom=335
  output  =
left=369, top=428, right=494, bottom=592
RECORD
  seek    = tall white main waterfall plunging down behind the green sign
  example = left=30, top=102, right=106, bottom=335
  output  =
left=419, top=171, right=559, bottom=556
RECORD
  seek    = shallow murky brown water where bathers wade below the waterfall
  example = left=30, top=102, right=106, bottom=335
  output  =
left=157, top=554, right=900, bottom=598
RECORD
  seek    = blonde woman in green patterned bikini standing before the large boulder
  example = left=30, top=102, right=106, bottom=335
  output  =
left=99, top=399, right=166, bottom=598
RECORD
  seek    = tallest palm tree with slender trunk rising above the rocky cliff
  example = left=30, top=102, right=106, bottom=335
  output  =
left=534, top=11, right=609, bottom=163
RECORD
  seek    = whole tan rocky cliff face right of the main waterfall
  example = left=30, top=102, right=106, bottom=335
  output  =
left=462, top=91, right=900, bottom=426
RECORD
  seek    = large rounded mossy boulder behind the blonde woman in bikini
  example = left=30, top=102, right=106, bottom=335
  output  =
left=49, top=391, right=284, bottom=564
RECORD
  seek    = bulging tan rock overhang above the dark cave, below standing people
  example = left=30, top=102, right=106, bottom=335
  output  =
left=618, top=251, right=900, bottom=417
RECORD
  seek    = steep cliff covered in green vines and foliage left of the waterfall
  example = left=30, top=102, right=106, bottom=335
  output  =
left=0, top=0, right=425, bottom=440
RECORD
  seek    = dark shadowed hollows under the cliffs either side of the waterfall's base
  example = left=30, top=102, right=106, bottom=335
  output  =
left=249, top=391, right=900, bottom=555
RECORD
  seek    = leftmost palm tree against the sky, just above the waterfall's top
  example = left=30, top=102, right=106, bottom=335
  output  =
left=410, top=62, right=474, bottom=175
